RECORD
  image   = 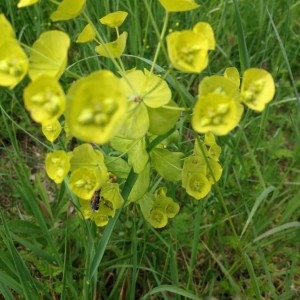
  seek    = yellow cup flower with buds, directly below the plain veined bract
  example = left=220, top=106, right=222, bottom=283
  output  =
left=23, top=75, right=65, bottom=124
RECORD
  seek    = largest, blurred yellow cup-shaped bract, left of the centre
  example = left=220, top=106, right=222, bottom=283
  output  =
left=66, top=70, right=127, bottom=144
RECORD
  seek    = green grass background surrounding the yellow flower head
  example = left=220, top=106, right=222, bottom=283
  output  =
left=0, top=0, right=300, bottom=300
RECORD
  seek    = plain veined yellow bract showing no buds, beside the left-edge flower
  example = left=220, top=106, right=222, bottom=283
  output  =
left=28, top=30, right=70, bottom=80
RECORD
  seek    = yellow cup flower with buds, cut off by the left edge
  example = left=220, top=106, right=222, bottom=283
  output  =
left=0, top=38, right=28, bottom=89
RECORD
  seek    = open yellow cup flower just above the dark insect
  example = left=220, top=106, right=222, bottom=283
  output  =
left=69, top=167, right=99, bottom=200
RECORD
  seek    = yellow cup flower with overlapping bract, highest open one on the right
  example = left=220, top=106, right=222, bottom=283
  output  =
left=167, top=22, right=215, bottom=73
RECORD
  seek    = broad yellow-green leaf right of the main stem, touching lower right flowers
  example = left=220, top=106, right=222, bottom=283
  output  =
left=150, top=148, right=183, bottom=181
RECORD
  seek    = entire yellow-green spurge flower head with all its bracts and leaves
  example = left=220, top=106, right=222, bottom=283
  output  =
left=0, top=0, right=275, bottom=228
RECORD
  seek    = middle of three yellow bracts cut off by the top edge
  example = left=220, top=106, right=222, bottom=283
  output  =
left=50, top=0, right=86, bottom=22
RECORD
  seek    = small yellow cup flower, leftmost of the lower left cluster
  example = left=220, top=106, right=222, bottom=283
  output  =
left=45, top=150, right=70, bottom=183
